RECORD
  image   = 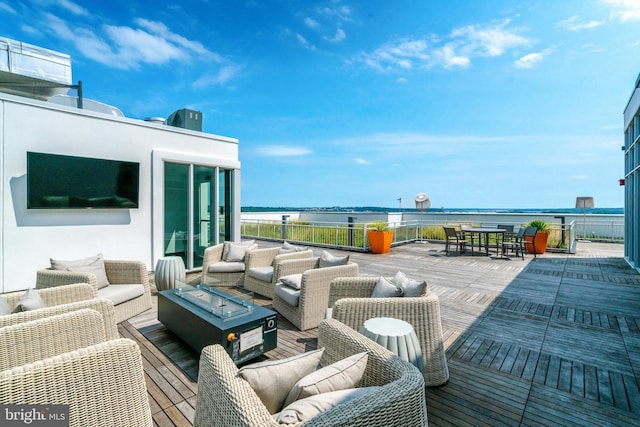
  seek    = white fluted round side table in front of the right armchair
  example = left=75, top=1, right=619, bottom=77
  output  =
left=360, top=317, right=424, bottom=372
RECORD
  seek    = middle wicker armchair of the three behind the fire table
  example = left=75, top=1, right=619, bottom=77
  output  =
left=244, top=247, right=316, bottom=298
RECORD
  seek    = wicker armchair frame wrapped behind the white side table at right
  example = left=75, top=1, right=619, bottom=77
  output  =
left=329, top=276, right=449, bottom=387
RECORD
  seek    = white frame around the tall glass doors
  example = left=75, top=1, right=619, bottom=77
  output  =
left=151, top=150, right=240, bottom=270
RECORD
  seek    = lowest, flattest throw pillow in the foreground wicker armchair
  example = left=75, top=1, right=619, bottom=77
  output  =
left=274, top=386, right=380, bottom=424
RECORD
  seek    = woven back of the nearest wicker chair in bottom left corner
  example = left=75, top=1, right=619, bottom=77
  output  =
left=0, top=338, right=153, bottom=426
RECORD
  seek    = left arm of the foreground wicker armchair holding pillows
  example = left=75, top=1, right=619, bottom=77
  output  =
left=194, top=344, right=278, bottom=427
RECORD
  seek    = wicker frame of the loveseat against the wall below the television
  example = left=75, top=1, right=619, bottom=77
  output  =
left=36, top=260, right=151, bottom=323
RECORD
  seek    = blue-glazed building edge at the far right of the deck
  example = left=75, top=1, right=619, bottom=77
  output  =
left=622, top=72, right=640, bottom=271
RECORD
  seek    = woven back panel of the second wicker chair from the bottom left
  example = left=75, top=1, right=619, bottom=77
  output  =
left=0, top=308, right=107, bottom=371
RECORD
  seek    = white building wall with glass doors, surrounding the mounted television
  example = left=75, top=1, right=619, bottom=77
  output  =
left=0, top=93, right=240, bottom=292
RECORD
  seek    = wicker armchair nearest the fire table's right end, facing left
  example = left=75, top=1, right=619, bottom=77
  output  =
left=273, top=263, right=358, bottom=331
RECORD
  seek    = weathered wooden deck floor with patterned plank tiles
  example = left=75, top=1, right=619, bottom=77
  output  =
left=119, top=243, right=640, bottom=426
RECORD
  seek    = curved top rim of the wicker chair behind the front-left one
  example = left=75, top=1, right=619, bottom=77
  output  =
left=0, top=298, right=120, bottom=340
